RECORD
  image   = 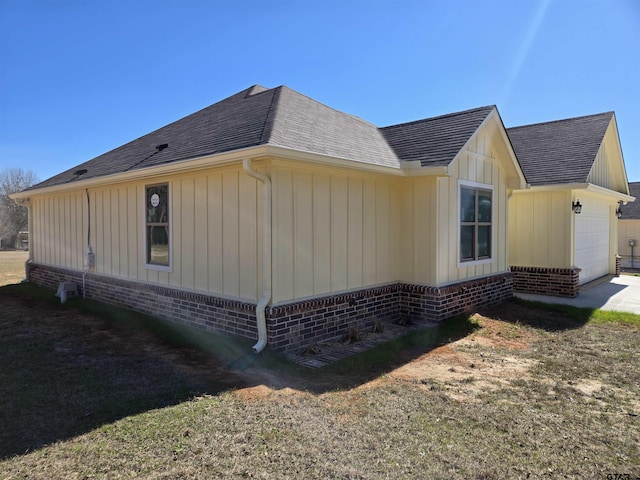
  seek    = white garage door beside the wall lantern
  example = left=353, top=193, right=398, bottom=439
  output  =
left=575, top=202, right=610, bottom=285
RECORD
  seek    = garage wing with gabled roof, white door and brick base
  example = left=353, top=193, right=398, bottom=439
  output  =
left=507, top=112, right=633, bottom=297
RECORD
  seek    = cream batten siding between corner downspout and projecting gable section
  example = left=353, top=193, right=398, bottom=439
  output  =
left=271, top=160, right=400, bottom=303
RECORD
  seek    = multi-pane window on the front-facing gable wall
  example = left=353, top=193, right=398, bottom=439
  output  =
left=460, top=185, right=493, bottom=262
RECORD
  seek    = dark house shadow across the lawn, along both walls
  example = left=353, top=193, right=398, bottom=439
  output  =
left=0, top=284, right=479, bottom=459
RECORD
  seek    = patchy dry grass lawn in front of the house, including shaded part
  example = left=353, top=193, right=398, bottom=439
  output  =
left=0, top=262, right=640, bottom=480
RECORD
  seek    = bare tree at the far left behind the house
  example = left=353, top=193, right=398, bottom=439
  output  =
left=0, top=168, right=39, bottom=247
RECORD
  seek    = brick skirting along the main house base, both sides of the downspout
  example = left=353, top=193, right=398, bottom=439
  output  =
left=29, top=263, right=513, bottom=351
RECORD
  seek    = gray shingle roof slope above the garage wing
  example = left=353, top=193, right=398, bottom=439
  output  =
left=507, top=112, right=613, bottom=185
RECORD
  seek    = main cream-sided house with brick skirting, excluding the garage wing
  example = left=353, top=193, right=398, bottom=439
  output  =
left=14, top=86, right=528, bottom=351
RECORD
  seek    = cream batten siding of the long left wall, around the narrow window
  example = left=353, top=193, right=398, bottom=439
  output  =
left=31, top=166, right=262, bottom=301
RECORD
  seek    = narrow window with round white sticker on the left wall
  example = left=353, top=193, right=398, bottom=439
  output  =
left=145, top=184, right=171, bottom=267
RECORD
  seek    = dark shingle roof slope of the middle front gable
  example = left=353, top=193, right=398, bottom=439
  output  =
left=380, top=105, right=495, bottom=167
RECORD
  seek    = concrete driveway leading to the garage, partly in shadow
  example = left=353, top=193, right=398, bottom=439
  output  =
left=515, top=274, right=640, bottom=315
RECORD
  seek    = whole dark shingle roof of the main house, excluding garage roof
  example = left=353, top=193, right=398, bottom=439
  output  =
left=27, top=85, right=495, bottom=190
